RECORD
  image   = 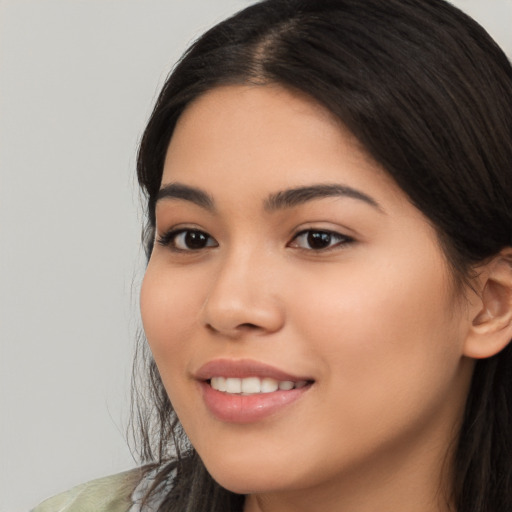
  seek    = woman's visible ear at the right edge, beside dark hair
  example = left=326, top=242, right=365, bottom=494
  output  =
left=464, top=247, right=512, bottom=359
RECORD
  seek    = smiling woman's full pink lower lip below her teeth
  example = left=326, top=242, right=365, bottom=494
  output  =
left=199, top=382, right=311, bottom=423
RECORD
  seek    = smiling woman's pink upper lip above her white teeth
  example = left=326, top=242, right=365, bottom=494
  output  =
left=194, top=359, right=313, bottom=382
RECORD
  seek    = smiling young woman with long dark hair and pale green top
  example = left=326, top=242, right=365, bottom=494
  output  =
left=33, top=0, right=512, bottom=512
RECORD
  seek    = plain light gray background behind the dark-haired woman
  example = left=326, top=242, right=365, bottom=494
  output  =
left=0, top=0, right=512, bottom=512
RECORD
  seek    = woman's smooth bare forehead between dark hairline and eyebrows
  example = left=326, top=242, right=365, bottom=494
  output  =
left=162, top=85, right=401, bottom=209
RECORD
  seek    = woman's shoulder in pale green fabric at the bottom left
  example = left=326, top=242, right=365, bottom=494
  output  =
left=32, top=469, right=144, bottom=512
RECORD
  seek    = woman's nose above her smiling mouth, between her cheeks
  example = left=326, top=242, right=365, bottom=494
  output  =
left=202, top=250, right=285, bottom=339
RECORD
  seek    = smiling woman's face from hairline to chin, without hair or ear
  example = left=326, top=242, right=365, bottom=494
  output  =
left=141, top=86, right=471, bottom=504
